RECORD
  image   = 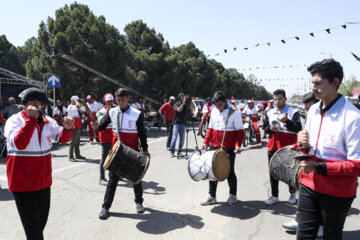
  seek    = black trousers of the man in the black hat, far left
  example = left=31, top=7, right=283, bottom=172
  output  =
left=13, top=187, right=51, bottom=240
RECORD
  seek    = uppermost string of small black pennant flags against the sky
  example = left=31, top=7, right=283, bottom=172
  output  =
left=207, top=21, right=360, bottom=57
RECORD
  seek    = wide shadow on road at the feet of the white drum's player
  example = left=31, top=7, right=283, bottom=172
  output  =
left=211, top=201, right=297, bottom=220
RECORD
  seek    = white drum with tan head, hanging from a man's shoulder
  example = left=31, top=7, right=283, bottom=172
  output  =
left=188, top=149, right=230, bottom=181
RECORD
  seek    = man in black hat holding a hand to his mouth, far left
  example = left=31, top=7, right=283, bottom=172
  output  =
left=4, top=88, right=73, bottom=239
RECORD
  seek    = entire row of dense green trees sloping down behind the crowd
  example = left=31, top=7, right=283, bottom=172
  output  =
left=0, top=2, right=271, bottom=103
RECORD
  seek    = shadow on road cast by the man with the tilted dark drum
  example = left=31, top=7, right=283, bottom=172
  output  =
left=110, top=208, right=204, bottom=234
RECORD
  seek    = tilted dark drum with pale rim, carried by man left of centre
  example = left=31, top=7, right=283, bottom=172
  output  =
left=103, top=141, right=150, bottom=184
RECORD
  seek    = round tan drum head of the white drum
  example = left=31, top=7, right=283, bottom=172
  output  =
left=212, top=149, right=230, bottom=181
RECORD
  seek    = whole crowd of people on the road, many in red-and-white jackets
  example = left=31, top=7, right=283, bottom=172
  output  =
left=2, top=59, right=360, bottom=240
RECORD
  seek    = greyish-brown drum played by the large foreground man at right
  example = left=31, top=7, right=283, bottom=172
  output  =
left=269, top=147, right=303, bottom=190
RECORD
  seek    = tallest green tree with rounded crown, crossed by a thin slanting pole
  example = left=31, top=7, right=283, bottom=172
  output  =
left=26, top=3, right=129, bottom=102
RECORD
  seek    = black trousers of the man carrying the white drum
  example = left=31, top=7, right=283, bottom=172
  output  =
left=209, top=146, right=237, bottom=197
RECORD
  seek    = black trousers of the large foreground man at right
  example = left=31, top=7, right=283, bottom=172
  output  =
left=296, top=185, right=355, bottom=240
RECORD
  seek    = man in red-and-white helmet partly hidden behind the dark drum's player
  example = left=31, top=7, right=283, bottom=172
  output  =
left=96, top=93, right=114, bottom=185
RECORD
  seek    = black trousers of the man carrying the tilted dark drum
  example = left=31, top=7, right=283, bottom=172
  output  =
left=102, top=172, right=144, bottom=209
